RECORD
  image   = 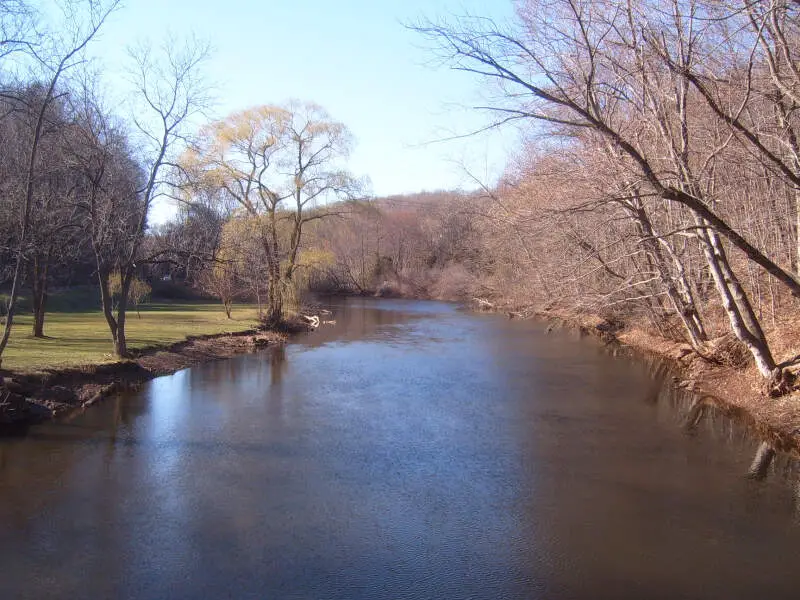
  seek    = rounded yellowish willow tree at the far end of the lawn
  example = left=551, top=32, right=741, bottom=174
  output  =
left=181, top=101, right=360, bottom=323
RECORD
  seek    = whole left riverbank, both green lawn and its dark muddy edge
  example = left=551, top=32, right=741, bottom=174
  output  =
left=0, top=302, right=310, bottom=433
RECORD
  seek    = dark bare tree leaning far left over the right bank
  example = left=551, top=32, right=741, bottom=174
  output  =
left=416, top=0, right=800, bottom=296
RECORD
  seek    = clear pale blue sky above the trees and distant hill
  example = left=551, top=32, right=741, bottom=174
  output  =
left=79, top=0, right=516, bottom=219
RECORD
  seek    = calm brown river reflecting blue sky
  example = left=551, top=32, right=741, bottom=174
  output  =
left=0, top=300, right=800, bottom=600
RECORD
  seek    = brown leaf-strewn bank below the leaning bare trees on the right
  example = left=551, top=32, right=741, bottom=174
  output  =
left=524, top=310, right=800, bottom=456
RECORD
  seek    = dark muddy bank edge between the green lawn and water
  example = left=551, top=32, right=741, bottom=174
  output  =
left=0, top=324, right=288, bottom=435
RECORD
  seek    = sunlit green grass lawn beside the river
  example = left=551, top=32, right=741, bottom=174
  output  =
left=3, top=303, right=258, bottom=371
